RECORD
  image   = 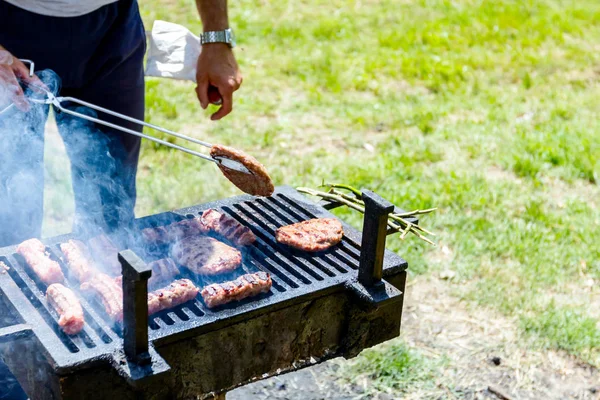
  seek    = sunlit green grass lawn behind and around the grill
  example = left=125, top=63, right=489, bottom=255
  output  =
left=45, top=0, right=600, bottom=394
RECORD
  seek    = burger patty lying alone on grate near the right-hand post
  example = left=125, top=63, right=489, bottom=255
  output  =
left=275, top=218, right=344, bottom=252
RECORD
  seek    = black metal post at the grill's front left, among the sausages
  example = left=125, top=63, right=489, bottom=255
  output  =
left=119, top=250, right=152, bottom=364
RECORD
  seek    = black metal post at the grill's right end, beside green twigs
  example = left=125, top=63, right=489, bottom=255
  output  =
left=358, top=190, right=394, bottom=286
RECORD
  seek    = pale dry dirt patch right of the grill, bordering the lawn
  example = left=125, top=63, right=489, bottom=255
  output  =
left=402, top=278, right=600, bottom=399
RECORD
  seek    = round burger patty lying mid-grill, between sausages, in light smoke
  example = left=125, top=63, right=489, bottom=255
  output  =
left=171, top=236, right=242, bottom=275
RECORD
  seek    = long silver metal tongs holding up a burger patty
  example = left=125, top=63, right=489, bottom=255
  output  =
left=0, top=60, right=252, bottom=175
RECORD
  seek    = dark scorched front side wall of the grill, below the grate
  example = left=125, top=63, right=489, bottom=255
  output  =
left=49, top=282, right=400, bottom=400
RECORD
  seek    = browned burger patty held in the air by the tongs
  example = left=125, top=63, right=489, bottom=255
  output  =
left=210, top=144, right=275, bottom=196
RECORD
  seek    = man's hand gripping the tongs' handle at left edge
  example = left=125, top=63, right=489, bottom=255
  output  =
left=0, top=46, right=43, bottom=111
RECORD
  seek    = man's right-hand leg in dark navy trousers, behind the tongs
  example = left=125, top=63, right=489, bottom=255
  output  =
left=57, top=0, right=146, bottom=231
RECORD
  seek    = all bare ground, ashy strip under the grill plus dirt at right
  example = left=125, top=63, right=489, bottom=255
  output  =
left=227, top=278, right=600, bottom=400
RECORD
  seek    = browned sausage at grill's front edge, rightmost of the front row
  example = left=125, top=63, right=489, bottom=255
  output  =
left=201, top=271, right=272, bottom=308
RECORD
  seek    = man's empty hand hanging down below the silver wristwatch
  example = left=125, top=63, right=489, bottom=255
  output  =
left=196, top=43, right=242, bottom=121
